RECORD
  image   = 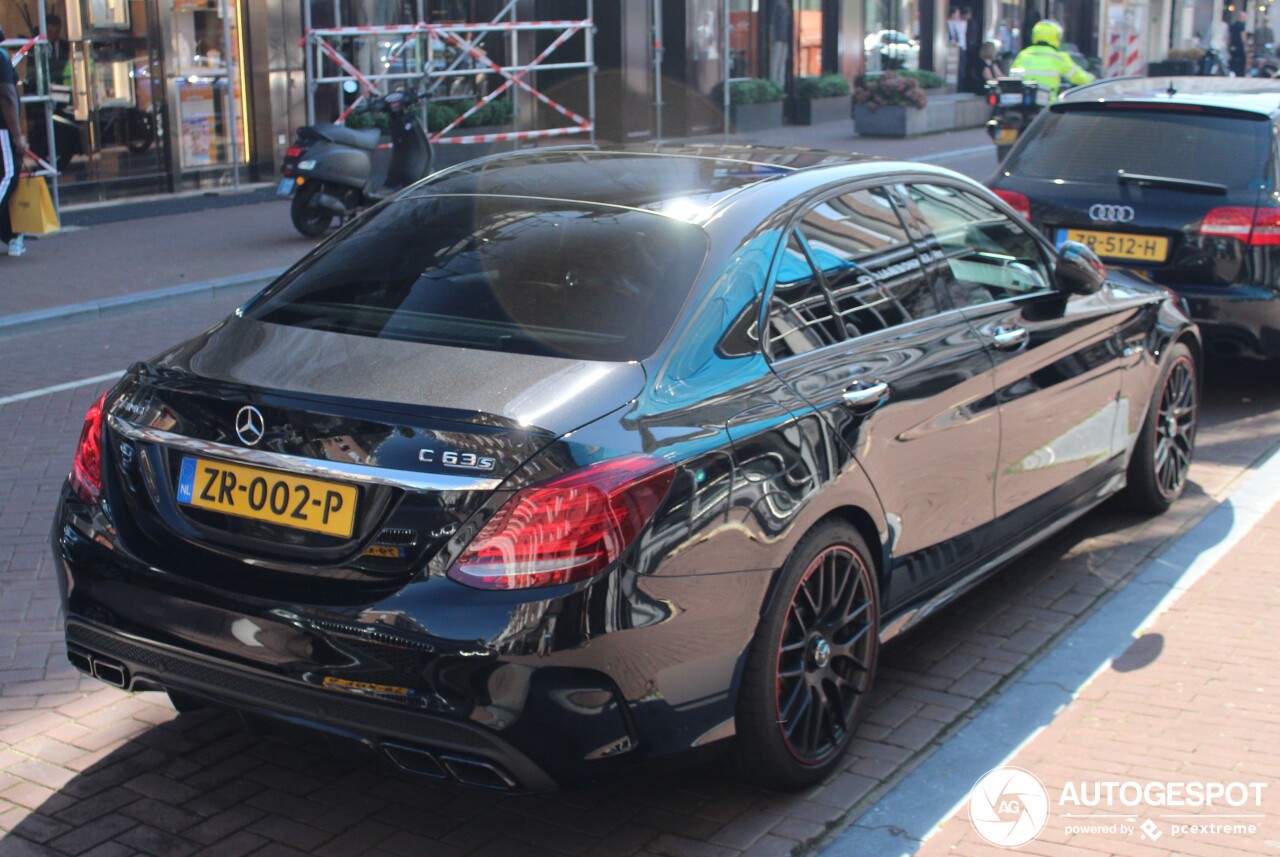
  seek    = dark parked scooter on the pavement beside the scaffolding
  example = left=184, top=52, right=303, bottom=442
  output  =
left=276, top=91, right=433, bottom=238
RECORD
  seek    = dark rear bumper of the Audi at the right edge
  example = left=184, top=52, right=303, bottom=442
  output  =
left=1170, top=285, right=1280, bottom=358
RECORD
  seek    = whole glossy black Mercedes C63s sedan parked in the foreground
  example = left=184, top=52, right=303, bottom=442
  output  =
left=52, top=147, right=1201, bottom=790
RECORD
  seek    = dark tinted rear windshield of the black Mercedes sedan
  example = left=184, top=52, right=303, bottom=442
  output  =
left=244, top=196, right=707, bottom=361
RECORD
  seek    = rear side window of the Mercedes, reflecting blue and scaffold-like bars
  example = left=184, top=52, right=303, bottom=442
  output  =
left=769, top=188, right=938, bottom=357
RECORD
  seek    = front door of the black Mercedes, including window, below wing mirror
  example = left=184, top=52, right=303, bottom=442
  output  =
left=905, top=180, right=1124, bottom=541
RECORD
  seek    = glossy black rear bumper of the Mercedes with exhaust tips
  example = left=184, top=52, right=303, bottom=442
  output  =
left=51, top=490, right=768, bottom=792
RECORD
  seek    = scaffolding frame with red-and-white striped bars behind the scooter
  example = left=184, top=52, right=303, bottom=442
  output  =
left=302, top=0, right=596, bottom=143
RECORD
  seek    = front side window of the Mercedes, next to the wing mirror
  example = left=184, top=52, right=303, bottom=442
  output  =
left=905, top=184, right=1050, bottom=307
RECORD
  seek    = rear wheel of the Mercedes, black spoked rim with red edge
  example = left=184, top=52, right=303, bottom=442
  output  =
left=735, top=522, right=879, bottom=789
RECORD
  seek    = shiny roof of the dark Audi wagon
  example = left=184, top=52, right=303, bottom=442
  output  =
left=1059, top=77, right=1280, bottom=116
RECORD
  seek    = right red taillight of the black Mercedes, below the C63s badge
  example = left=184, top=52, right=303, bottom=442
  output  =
left=449, top=455, right=676, bottom=590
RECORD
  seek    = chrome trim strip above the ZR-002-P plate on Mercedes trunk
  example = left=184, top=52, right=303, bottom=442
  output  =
left=106, top=413, right=502, bottom=491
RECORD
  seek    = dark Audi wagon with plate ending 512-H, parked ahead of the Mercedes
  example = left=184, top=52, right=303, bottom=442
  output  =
left=988, top=77, right=1280, bottom=358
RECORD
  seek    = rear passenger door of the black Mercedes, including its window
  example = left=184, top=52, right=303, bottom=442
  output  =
left=765, top=187, right=1000, bottom=609
